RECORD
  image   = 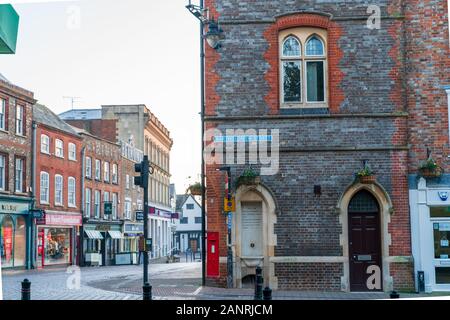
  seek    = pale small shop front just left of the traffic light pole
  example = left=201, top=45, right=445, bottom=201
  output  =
left=116, top=222, right=144, bottom=265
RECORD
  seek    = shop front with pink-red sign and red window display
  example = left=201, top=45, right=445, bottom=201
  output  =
left=36, top=211, right=82, bottom=268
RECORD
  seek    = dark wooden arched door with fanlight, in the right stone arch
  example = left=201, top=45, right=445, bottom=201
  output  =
left=348, top=189, right=383, bottom=291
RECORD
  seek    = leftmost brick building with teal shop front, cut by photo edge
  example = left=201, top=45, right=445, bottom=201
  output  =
left=0, top=75, right=36, bottom=268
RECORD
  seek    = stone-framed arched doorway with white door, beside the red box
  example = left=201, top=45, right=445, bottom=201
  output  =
left=232, top=185, right=277, bottom=289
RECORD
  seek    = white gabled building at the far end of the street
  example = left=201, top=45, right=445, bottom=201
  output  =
left=175, top=194, right=202, bottom=252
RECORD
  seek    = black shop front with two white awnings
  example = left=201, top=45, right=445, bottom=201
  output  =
left=83, top=224, right=123, bottom=266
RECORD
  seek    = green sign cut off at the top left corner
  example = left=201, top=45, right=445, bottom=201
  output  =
left=0, top=4, right=19, bottom=54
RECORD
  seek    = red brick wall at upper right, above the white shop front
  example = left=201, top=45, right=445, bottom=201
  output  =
left=405, top=0, right=450, bottom=174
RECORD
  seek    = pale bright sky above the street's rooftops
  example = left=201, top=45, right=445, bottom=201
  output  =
left=0, top=0, right=201, bottom=193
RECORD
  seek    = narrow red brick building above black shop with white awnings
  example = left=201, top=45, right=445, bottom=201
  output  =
left=74, top=127, right=123, bottom=266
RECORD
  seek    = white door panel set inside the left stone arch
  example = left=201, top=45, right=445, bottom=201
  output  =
left=241, top=202, right=264, bottom=257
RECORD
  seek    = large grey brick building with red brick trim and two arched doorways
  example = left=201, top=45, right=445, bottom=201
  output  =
left=201, top=0, right=440, bottom=291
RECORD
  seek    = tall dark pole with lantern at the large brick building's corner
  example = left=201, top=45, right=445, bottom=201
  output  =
left=186, top=0, right=223, bottom=286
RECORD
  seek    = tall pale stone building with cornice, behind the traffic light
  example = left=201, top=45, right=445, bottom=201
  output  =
left=60, top=104, right=174, bottom=258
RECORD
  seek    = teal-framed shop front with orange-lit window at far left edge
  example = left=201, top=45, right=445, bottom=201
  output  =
left=0, top=199, right=31, bottom=268
